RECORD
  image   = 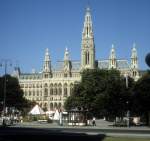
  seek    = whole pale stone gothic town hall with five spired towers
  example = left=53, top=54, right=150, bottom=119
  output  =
left=15, top=7, right=139, bottom=110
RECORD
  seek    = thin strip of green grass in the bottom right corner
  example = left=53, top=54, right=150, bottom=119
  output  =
left=103, top=137, right=150, bottom=141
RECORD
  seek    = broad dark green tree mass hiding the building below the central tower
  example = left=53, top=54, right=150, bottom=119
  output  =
left=65, top=69, right=133, bottom=117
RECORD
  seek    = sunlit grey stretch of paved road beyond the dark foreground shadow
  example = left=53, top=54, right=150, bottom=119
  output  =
left=7, top=121, right=150, bottom=138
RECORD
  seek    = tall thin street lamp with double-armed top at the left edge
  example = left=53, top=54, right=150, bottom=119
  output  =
left=0, top=59, right=12, bottom=115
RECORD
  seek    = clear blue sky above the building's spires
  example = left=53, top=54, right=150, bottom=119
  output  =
left=0, top=0, right=150, bottom=72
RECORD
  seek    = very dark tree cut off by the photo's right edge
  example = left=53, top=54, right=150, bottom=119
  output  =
left=132, top=71, right=150, bottom=125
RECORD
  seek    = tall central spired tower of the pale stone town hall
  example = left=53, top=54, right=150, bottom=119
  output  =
left=81, top=7, right=95, bottom=70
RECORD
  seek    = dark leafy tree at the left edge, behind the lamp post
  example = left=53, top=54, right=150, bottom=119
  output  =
left=0, top=75, right=34, bottom=113
